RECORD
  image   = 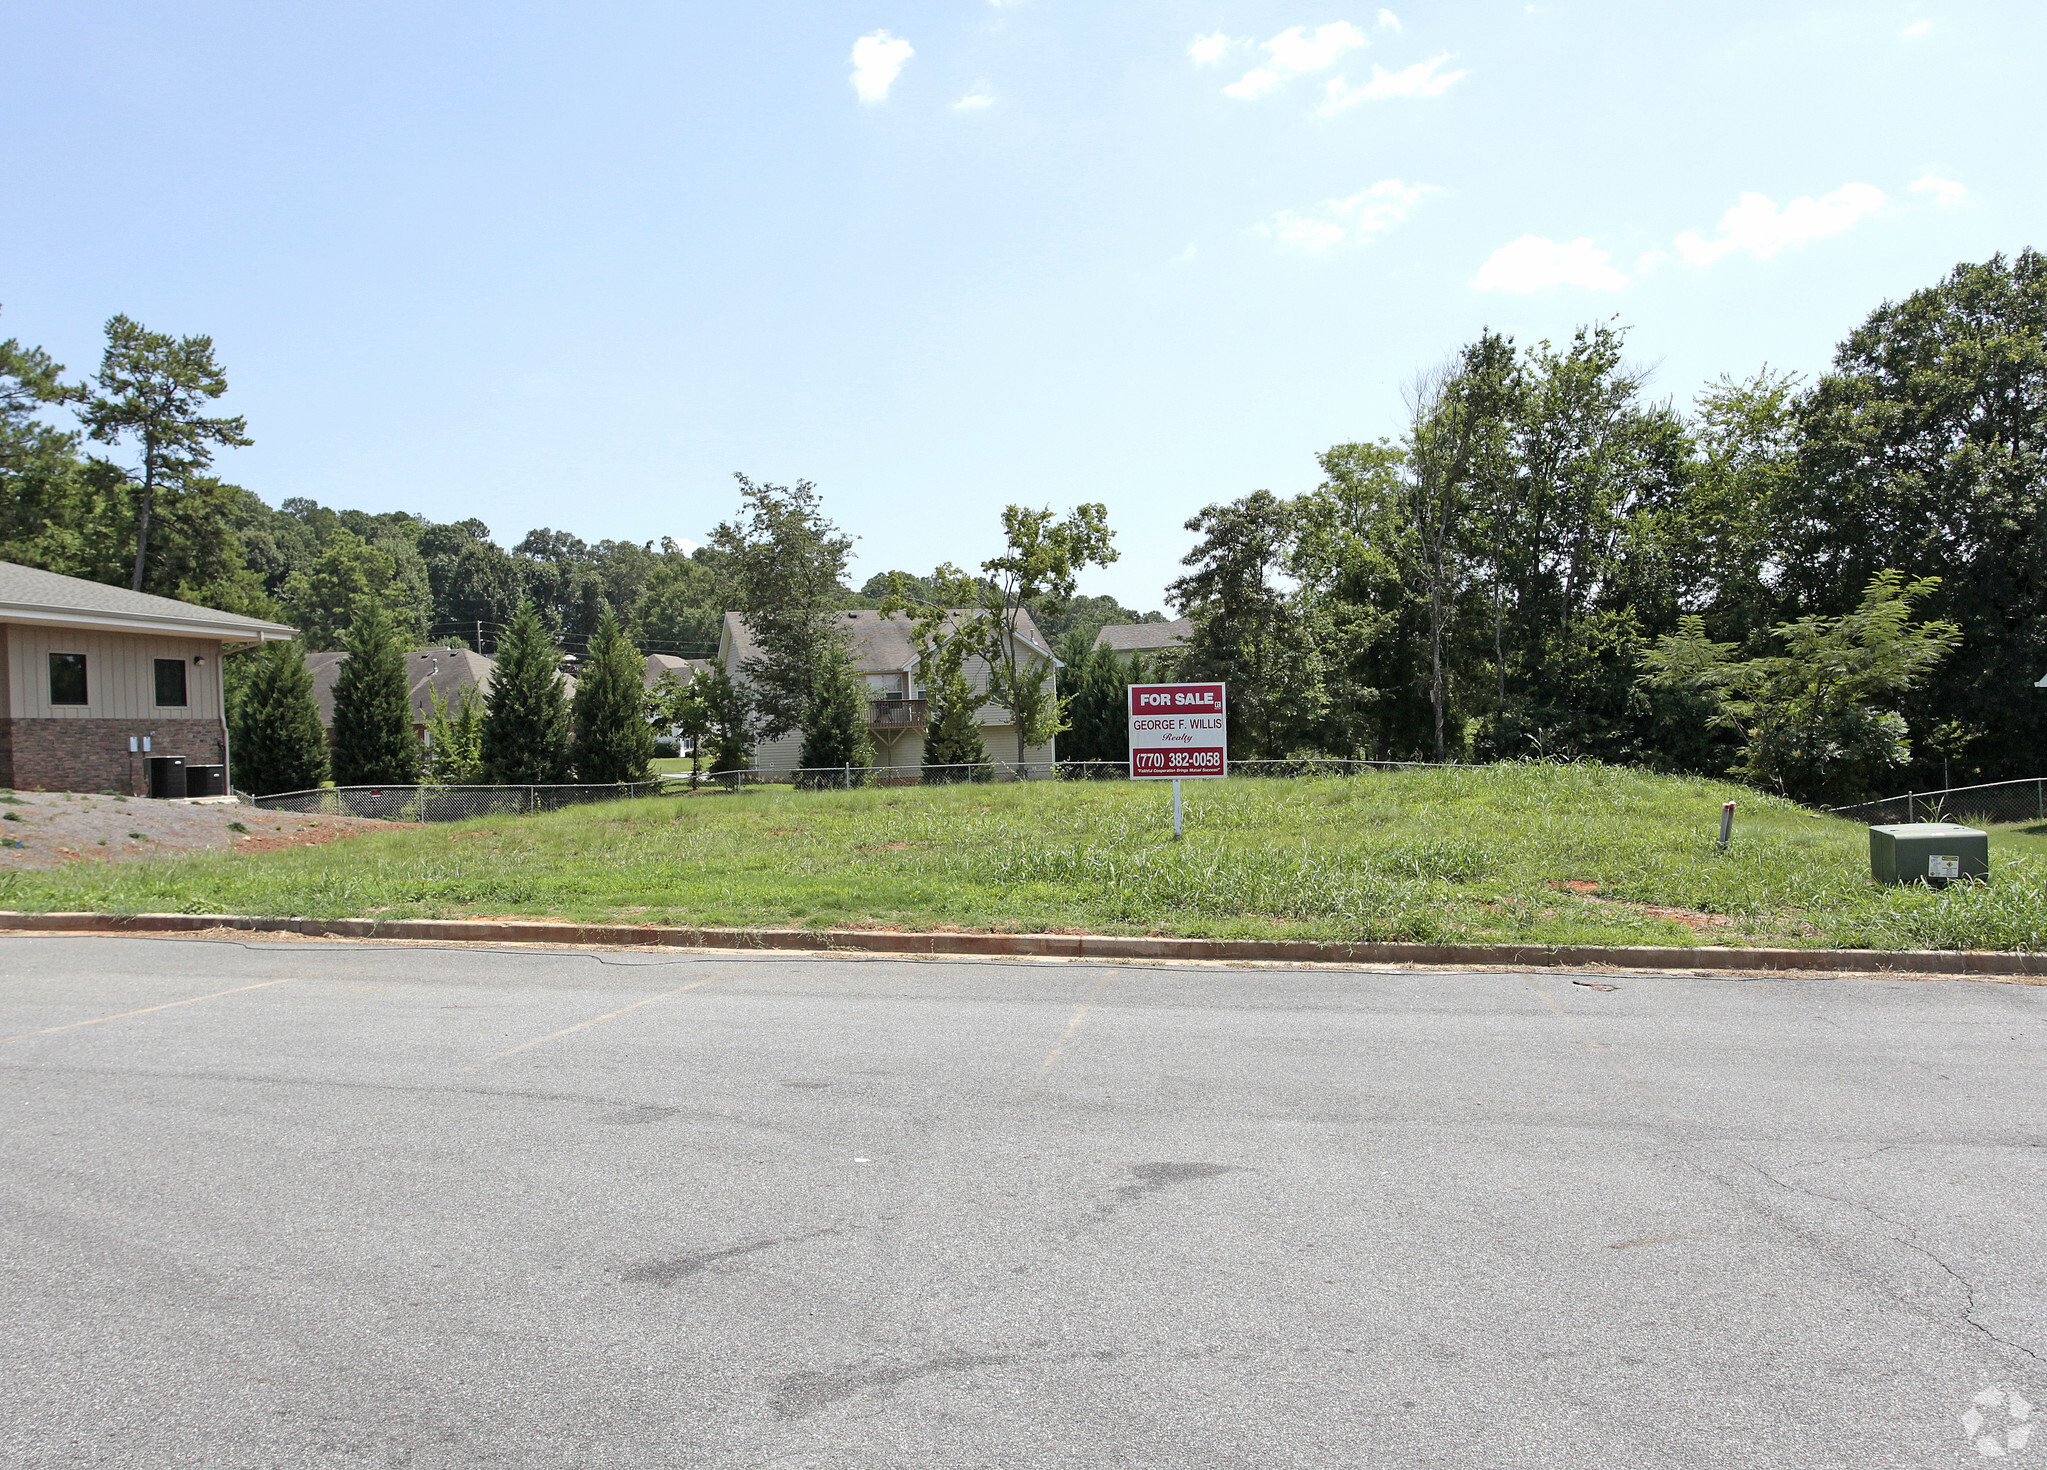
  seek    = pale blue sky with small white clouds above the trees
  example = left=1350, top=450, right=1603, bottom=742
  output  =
left=0, top=0, right=2047, bottom=608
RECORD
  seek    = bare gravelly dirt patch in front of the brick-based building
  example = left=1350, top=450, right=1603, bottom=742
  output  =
left=0, top=790, right=407, bottom=872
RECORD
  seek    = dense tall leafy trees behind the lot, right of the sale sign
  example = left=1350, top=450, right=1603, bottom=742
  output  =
left=1069, top=250, right=2047, bottom=803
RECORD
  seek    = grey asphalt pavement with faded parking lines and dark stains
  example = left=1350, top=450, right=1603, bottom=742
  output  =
left=0, top=938, right=2047, bottom=1470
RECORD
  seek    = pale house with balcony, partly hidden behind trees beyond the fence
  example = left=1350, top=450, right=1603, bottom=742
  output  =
left=718, top=610, right=1058, bottom=776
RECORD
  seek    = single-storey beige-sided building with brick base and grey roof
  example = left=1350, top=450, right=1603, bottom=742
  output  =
left=0, top=561, right=293, bottom=796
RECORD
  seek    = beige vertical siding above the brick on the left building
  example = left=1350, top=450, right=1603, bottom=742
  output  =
left=4, top=624, right=221, bottom=721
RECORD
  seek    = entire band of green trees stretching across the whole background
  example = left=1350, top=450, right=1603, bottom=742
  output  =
left=0, top=250, right=2047, bottom=801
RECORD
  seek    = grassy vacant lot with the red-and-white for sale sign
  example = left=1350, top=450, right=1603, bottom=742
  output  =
left=0, top=766, right=2047, bottom=948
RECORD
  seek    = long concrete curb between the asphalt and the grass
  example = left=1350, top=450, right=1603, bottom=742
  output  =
left=0, top=913, right=2047, bottom=975
